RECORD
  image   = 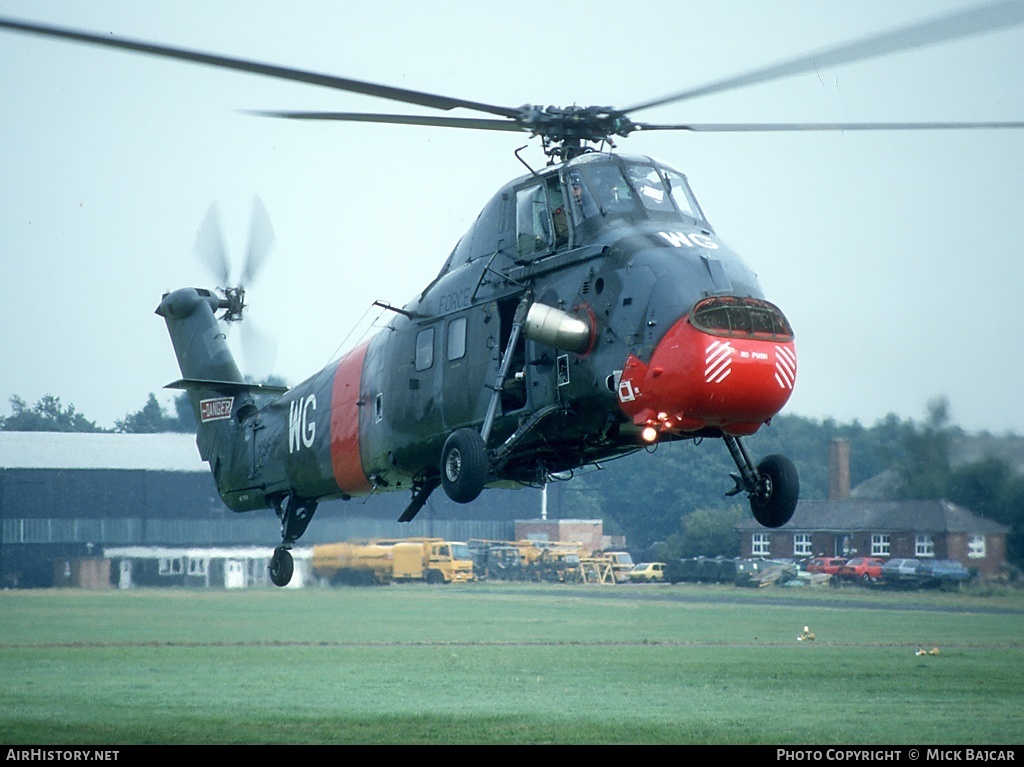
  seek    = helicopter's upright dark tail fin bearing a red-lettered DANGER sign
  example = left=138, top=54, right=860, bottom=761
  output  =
left=151, top=288, right=285, bottom=462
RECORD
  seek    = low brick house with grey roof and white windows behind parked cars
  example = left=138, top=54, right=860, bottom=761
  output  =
left=736, top=499, right=1010, bottom=576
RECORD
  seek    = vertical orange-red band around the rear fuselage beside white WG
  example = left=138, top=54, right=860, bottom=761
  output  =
left=331, top=342, right=371, bottom=495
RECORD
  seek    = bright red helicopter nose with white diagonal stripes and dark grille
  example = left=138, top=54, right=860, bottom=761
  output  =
left=618, top=297, right=797, bottom=439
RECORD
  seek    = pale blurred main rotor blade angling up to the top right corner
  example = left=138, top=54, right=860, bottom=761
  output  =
left=622, top=0, right=1024, bottom=113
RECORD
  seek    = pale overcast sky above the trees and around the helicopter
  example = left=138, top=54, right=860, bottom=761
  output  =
left=0, top=0, right=1024, bottom=433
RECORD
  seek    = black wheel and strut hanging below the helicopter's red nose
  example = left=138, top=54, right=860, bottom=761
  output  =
left=723, top=436, right=800, bottom=527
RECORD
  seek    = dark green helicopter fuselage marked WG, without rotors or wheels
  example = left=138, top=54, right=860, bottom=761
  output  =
left=159, top=154, right=795, bottom=511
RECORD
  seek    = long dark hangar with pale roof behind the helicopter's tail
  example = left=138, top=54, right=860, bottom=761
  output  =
left=0, top=431, right=512, bottom=588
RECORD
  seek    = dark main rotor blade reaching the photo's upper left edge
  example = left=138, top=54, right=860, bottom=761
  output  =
left=0, top=17, right=519, bottom=118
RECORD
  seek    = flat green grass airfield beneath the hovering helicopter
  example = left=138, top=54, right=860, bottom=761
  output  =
left=0, top=584, right=1024, bottom=744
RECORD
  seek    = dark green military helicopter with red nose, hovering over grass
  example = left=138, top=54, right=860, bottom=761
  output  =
left=0, top=0, right=1024, bottom=586
